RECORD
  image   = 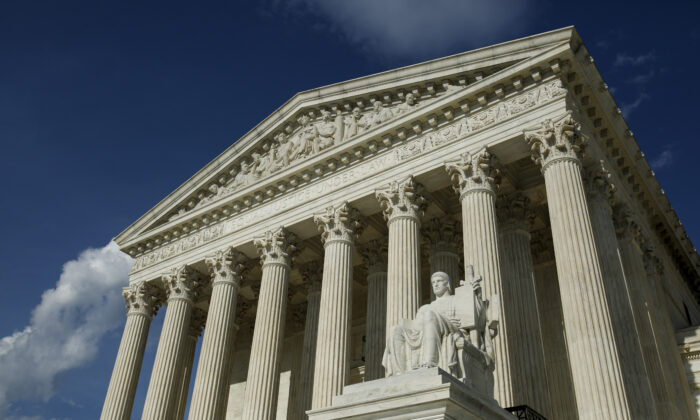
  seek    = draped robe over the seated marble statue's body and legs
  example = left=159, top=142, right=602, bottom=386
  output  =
left=382, top=294, right=464, bottom=376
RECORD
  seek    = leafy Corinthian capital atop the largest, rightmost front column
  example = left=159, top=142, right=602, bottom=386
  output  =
left=523, top=111, right=587, bottom=172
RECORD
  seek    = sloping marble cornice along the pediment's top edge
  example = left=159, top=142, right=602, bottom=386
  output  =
left=115, top=27, right=580, bottom=247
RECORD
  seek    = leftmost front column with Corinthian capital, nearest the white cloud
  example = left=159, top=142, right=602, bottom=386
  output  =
left=100, top=283, right=160, bottom=420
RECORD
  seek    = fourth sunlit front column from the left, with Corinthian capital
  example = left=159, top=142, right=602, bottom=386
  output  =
left=242, top=227, right=296, bottom=420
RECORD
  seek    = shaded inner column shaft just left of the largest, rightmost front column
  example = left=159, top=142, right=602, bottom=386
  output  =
left=535, top=261, right=578, bottom=419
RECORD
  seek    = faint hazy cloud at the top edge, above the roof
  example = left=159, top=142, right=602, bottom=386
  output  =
left=269, top=0, right=531, bottom=58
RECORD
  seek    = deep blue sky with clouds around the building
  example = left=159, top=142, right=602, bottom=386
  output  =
left=0, top=0, right=700, bottom=419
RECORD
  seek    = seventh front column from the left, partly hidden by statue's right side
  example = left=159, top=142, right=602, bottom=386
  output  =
left=445, top=148, right=513, bottom=407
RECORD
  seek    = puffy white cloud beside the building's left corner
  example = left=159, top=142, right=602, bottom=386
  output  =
left=0, top=242, right=133, bottom=418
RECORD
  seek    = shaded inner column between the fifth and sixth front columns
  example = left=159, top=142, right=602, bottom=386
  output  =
left=358, top=237, right=388, bottom=382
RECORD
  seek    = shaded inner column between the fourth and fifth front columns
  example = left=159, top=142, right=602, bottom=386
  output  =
left=290, top=261, right=323, bottom=420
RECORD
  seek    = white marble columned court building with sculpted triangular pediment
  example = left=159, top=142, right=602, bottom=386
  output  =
left=102, top=27, right=700, bottom=420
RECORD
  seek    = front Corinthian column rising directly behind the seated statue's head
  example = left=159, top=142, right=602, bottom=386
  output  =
left=375, top=176, right=425, bottom=340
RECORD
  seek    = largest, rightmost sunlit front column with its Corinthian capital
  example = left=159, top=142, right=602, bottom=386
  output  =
left=525, top=113, right=630, bottom=420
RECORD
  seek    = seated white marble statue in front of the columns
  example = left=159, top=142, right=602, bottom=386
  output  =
left=382, top=266, right=499, bottom=397
